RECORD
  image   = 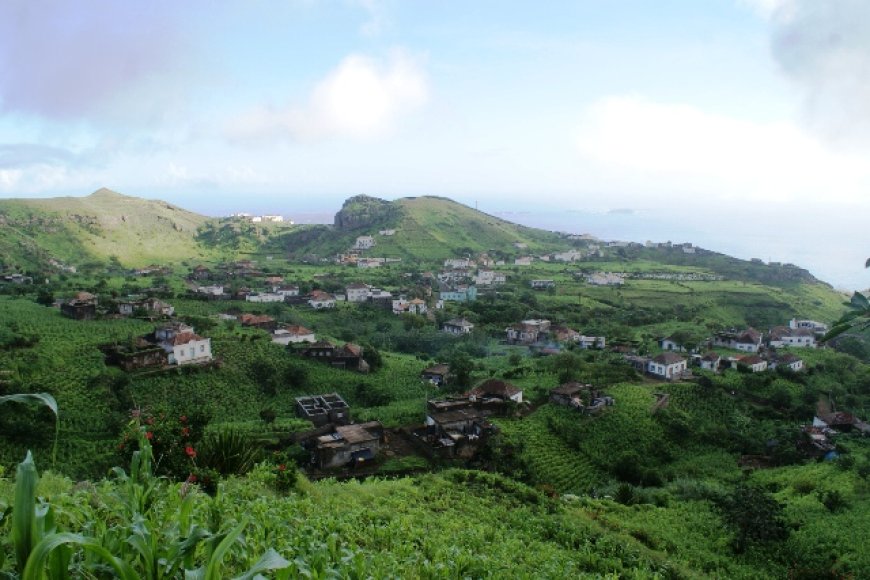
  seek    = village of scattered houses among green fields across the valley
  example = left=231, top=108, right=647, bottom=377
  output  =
left=0, top=193, right=870, bottom=576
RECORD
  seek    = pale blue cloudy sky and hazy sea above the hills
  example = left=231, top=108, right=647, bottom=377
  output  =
left=0, top=0, right=870, bottom=287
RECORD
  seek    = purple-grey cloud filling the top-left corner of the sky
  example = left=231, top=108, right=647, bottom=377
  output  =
left=0, top=0, right=192, bottom=119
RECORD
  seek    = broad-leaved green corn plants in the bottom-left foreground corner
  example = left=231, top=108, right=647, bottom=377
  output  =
left=0, top=444, right=290, bottom=580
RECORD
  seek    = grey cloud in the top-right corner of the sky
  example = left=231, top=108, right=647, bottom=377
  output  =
left=755, top=0, right=870, bottom=146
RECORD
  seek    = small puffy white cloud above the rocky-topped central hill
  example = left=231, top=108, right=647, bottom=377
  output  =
left=227, top=51, right=429, bottom=142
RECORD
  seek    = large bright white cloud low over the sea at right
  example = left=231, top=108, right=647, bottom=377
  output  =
left=578, top=97, right=870, bottom=208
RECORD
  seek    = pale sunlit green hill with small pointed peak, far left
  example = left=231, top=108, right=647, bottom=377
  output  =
left=0, top=189, right=208, bottom=268
